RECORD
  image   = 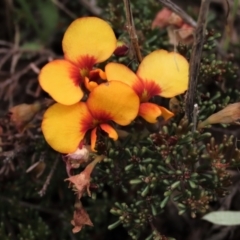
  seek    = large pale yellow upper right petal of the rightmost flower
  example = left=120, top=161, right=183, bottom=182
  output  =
left=137, top=50, right=189, bottom=97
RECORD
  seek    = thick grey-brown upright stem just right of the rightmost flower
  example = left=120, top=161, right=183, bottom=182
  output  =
left=186, top=0, right=210, bottom=123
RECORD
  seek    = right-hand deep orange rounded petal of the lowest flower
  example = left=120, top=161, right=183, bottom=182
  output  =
left=86, top=81, right=139, bottom=126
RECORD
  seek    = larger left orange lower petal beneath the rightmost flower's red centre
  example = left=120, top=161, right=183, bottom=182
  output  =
left=138, top=103, right=161, bottom=123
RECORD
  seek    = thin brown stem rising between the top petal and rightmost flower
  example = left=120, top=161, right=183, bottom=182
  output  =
left=123, top=0, right=142, bottom=63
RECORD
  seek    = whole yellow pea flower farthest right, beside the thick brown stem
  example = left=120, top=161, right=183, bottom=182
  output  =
left=105, top=50, right=189, bottom=123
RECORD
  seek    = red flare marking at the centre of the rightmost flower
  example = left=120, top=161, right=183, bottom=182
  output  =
left=133, top=77, right=162, bottom=102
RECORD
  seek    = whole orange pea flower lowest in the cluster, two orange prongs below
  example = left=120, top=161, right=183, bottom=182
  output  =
left=42, top=81, right=139, bottom=153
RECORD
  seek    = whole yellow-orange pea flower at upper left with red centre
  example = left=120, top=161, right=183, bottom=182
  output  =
left=39, top=17, right=117, bottom=105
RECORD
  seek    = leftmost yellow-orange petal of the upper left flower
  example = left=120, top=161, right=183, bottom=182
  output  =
left=39, top=60, right=83, bottom=105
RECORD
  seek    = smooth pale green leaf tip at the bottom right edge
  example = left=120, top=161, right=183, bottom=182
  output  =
left=202, top=211, right=240, bottom=226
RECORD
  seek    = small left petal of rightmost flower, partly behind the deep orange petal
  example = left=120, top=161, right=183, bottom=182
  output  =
left=105, top=62, right=138, bottom=87
